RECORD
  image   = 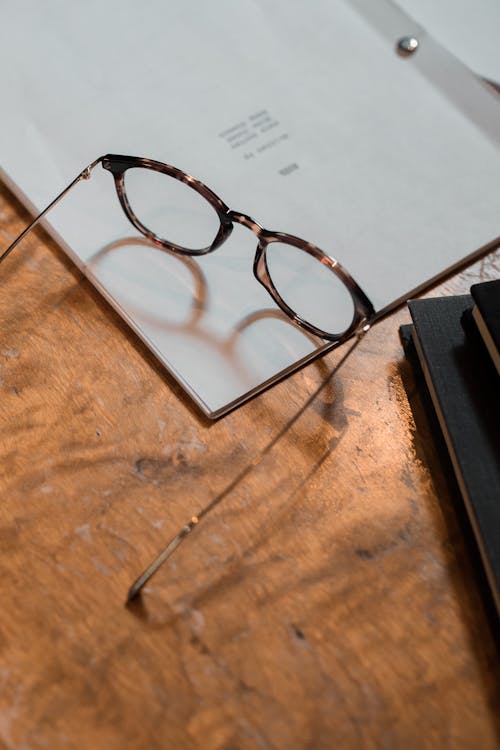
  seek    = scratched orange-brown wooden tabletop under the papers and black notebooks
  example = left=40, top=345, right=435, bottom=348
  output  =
left=0, top=184, right=500, bottom=750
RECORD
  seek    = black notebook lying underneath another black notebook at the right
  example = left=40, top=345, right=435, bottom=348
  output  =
left=408, top=295, right=500, bottom=611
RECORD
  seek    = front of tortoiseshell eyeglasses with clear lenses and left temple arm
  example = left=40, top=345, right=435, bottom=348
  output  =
left=0, top=154, right=374, bottom=342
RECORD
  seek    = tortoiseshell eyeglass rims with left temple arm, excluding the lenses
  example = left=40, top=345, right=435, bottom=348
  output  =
left=0, top=154, right=375, bottom=342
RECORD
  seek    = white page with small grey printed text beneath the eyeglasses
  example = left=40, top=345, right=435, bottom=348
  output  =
left=0, top=0, right=500, bottom=415
